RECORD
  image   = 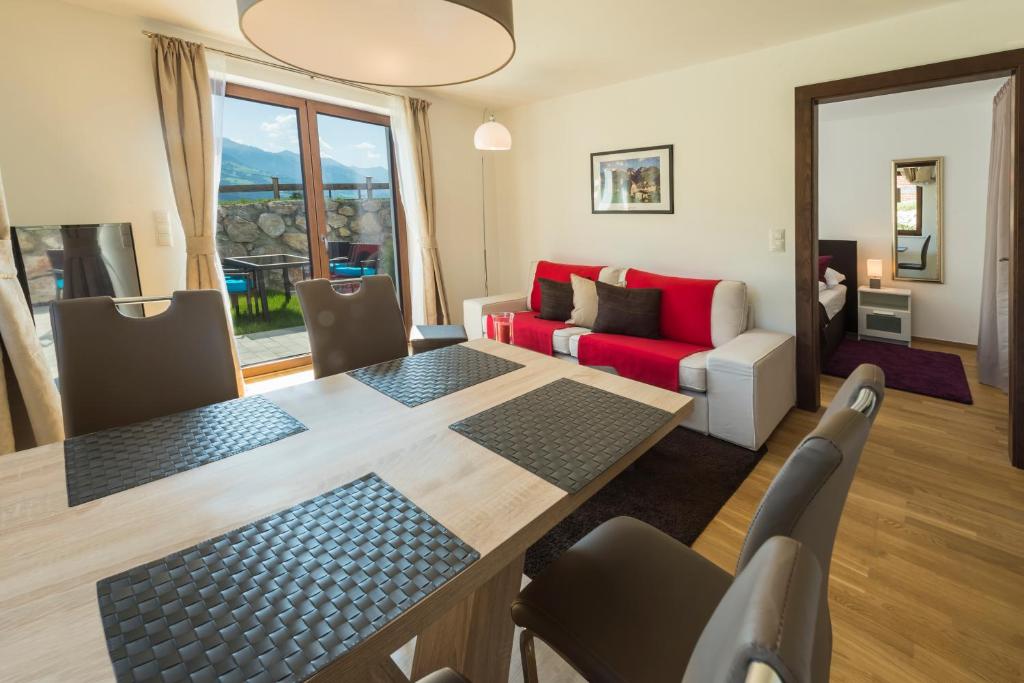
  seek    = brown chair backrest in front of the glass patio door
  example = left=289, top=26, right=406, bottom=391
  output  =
left=295, top=275, right=409, bottom=379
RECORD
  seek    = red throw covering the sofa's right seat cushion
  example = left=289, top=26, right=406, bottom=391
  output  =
left=579, top=333, right=710, bottom=391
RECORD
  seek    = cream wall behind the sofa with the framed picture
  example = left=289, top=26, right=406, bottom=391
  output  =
left=496, top=0, right=1024, bottom=331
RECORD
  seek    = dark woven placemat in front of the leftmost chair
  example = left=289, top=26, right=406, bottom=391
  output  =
left=65, top=396, right=306, bottom=507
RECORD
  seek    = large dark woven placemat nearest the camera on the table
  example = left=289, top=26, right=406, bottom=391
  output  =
left=96, top=474, right=479, bottom=681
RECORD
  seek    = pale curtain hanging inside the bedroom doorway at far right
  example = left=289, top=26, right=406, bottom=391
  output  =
left=978, top=78, right=1015, bottom=391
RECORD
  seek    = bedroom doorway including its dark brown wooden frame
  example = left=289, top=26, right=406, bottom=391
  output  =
left=796, top=51, right=1024, bottom=467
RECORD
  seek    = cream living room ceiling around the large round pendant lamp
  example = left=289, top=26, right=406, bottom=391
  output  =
left=65, top=0, right=954, bottom=108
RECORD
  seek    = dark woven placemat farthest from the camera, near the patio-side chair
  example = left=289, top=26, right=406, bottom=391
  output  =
left=348, top=346, right=522, bottom=408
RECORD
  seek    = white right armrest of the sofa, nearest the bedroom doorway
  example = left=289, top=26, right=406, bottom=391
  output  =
left=708, top=329, right=797, bottom=450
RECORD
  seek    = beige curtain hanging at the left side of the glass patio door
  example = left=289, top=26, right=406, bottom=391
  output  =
left=153, top=35, right=245, bottom=394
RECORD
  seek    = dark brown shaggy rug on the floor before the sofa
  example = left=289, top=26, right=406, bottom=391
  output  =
left=525, top=427, right=765, bottom=579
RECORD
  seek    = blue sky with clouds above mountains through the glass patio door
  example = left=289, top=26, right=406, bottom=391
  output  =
left=223, top=97, right=387, bottom=168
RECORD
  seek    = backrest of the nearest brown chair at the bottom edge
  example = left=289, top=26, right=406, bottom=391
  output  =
left=683, top=537, right=825, bottom=683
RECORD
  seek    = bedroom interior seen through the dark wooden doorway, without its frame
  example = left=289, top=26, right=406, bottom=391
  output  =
left=817, top=77, right=1011, bottom=411
